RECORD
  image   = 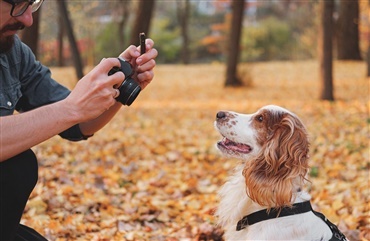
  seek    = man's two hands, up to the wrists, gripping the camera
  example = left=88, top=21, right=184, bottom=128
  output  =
left=65, top=39, right=158, bottom=122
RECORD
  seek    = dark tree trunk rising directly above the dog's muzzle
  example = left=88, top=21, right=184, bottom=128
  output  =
left=225, top=0, right=244, bottom=86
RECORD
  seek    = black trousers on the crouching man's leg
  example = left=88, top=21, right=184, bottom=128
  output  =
left=0, top=150, right=46, bottom=241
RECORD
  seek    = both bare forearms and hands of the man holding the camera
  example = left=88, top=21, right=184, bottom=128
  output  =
left=0, top=39, right=158, bottom=162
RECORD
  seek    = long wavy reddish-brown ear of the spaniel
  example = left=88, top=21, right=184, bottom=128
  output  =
left=243, top=114, right=309, bottom=208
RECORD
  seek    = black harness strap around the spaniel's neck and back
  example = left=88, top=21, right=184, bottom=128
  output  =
left=236, top=201, right=347, bottom=241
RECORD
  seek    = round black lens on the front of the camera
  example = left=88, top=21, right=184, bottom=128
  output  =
left=116, top=78, right=141, bottom=106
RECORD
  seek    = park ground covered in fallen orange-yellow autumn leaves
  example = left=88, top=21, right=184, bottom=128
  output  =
left=22, top=62, right=370, bottom=241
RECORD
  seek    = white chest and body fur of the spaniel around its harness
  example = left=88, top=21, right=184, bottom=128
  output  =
left=216, top=169, right=332, bottom=240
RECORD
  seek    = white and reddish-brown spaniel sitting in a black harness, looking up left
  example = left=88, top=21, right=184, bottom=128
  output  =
left=215, top=105, right=347, bottom=241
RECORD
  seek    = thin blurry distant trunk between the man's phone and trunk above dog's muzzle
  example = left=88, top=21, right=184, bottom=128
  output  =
left=177, top=0, right=190, bottom=64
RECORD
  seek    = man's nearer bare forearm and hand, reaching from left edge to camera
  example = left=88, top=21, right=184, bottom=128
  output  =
left=0, top=58, right=124, bottom=161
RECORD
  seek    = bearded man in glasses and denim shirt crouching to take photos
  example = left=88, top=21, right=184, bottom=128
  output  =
left=0, top=0, right=158, bottom=241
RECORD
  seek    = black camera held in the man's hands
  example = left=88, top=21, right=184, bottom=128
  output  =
left=108, top=58, right=141, bottom=106
